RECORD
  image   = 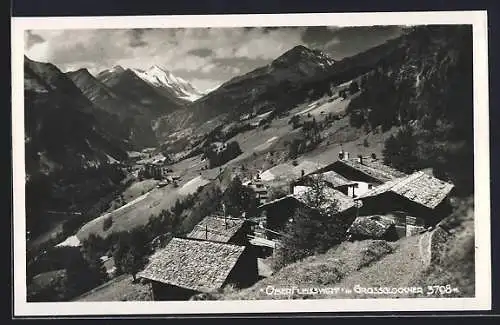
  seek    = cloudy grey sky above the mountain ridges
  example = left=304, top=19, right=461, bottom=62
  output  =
left=25, top=26, right=402, bottom=91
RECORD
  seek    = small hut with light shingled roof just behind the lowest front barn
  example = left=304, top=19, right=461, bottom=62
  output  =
left=186, top=216, right=250, bottom=246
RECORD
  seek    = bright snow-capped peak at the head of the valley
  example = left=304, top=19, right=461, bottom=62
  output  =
left=132, top=65, right=203, bottom=101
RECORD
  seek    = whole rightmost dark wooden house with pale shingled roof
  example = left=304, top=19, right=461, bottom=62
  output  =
left=358, top=171, right=454, bottom=226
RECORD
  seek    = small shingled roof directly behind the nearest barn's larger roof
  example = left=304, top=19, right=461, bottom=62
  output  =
left=186, top=216, right=245, bottom=243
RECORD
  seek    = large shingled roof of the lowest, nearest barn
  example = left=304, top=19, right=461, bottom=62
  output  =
left=137, top=238, right=245, bottom=292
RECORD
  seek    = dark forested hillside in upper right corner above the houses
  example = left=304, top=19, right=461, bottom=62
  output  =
left=348, top=26, right=474, bottom=194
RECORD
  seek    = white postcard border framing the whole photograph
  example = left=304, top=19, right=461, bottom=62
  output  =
left=11, top=11, right=491, bottom=316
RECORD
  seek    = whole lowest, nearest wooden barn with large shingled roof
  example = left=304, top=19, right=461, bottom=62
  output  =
left=137, top=238, right=258, bottom=300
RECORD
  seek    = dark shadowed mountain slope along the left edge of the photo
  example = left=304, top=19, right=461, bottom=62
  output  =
left=24, top=57, right=127, bottom=237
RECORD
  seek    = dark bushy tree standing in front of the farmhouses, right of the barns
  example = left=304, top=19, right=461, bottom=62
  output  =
left=273, top=177, right=352, bottom=269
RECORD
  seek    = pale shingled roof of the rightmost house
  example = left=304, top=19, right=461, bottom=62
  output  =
left=358, top=171, right=454, bottom=209
